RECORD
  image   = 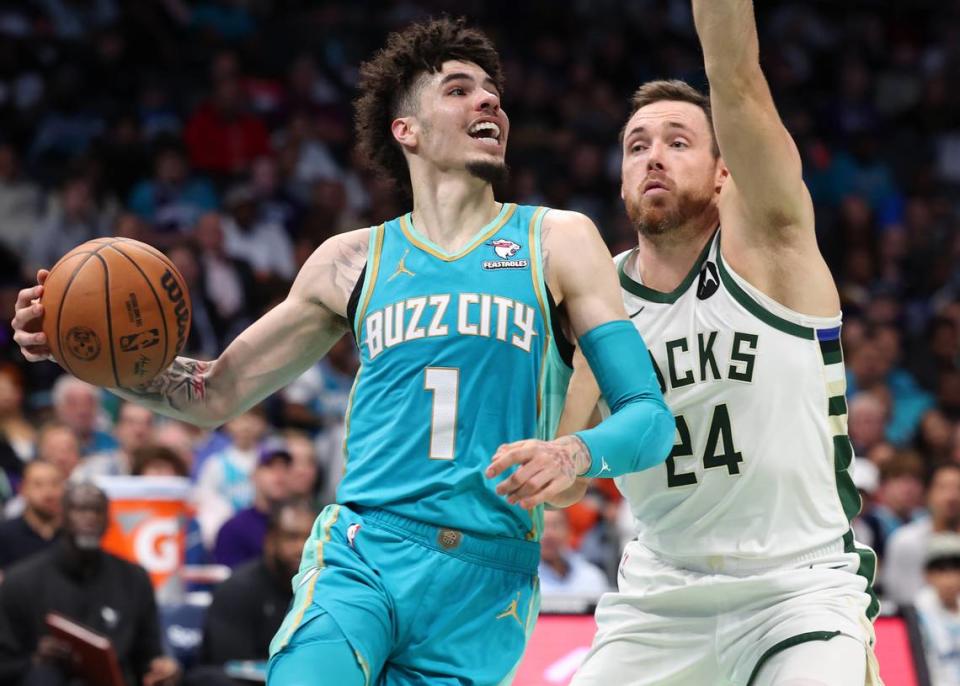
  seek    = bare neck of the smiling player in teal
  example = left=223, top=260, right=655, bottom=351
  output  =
left=413, top=175, right=501, bottom=253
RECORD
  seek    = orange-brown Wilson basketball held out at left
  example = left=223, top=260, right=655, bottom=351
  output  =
left=41, top=238, right=191, bottom=388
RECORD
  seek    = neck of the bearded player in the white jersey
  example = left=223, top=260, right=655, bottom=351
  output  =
left=627, top=213, right=718, bottom=293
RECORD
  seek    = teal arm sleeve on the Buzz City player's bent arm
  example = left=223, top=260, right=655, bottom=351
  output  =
left=576, top=320, right=676, bottom=477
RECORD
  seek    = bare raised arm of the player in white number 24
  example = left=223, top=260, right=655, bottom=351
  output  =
left=692, top=0, right=840, bottom=316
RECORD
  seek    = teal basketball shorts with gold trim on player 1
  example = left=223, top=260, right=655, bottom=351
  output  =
left=268, top=505, right=540, bottom=686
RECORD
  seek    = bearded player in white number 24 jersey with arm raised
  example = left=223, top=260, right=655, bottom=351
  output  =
left=560, top=0, right=879, bottom=686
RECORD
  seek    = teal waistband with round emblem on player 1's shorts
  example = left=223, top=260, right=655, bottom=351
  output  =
left=350, top=506, right=540, bottom=575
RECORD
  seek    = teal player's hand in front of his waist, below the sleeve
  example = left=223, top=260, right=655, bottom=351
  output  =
left=486, top=436, right=590, bottom=510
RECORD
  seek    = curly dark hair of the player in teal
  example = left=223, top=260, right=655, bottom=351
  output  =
left=354, top=17, right=504, bottom=193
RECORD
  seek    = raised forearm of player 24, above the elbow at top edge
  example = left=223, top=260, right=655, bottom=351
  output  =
left=693, top=0, right=762, bottom=84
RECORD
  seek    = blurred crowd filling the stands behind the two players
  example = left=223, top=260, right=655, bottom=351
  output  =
left=0, top=0, right=960, bottom=683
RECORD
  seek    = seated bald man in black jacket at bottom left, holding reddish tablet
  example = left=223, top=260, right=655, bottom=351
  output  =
left=0, top=483, right=179, bottom=686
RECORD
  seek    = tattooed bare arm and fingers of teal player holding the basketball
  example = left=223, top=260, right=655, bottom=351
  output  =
left=14, top=229, right=370, bottom=427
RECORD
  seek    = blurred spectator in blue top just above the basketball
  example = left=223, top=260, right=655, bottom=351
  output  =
left=127, top=138, right=217, bottom=241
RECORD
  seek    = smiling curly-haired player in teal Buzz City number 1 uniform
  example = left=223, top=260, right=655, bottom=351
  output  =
left=14, top=20, right=674, bottom=686
